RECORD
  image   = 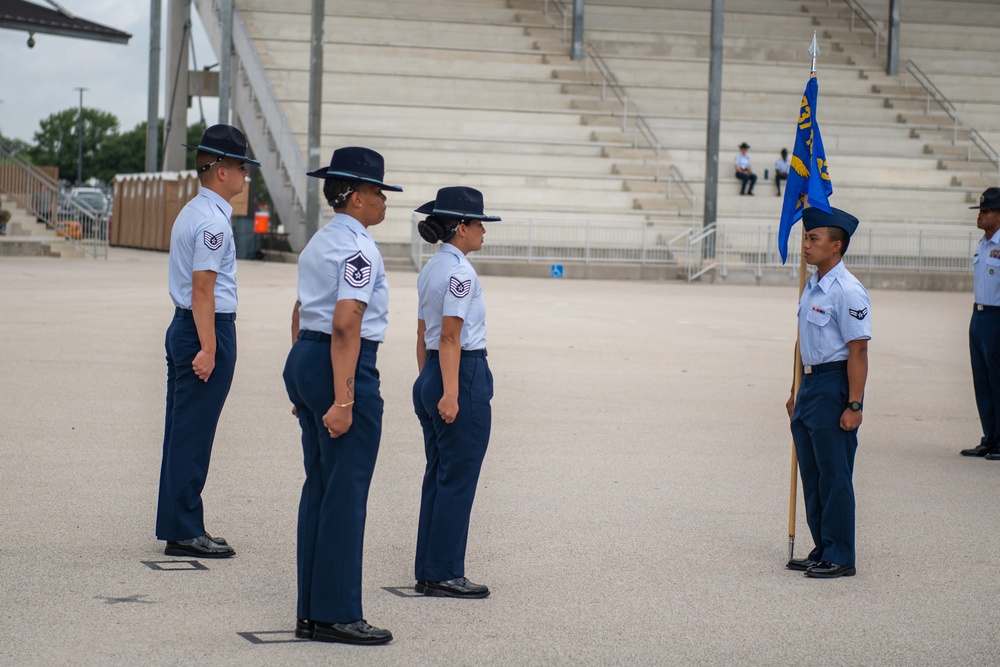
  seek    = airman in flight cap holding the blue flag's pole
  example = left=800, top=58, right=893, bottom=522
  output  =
left=785, top=208, right=872, bottom=579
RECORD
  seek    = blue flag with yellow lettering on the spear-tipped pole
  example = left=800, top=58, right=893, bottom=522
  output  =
left=778, top=74, right=833, bottom=264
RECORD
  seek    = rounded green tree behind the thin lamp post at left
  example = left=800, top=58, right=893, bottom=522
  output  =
left=29, top=107, right=118, bottom=180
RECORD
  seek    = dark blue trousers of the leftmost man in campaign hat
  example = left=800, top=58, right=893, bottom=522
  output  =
left=156, top=308, right=236, bottom=540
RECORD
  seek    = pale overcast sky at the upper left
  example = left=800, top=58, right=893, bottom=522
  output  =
left=0, top=0, right=219, bottom=142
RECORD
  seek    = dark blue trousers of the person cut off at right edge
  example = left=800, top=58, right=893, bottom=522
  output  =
left=969, top=309, right=1000, bottom=445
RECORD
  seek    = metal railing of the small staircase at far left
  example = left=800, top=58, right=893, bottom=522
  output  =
left=0, top=146, right=110, bottom=259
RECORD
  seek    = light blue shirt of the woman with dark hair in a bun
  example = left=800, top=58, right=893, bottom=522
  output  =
left=417, top=243, right=486, bottom=350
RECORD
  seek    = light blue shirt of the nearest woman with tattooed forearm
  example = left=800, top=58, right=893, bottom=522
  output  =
left=298, top=213, right=389, bottom=343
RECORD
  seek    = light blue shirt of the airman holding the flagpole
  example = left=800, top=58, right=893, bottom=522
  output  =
left=799, top=262, right=872, bottom=365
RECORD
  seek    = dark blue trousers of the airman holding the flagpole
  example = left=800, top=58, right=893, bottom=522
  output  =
left=792, top=369, right=858, bottom=567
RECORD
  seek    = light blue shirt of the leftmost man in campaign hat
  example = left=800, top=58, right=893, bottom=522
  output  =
left=169, top=188, right=237, bottom=313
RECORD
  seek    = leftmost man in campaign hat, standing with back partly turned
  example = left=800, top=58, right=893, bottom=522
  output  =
left=156, top=125, right=260, bottom=558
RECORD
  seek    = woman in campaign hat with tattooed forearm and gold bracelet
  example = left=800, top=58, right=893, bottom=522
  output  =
left=284, top=147, right=402, bottom=644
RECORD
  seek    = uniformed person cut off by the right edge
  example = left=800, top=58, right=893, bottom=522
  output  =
left=962, top=188, right=1000, bottom=461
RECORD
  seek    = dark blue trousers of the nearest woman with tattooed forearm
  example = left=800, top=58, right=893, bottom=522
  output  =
left=284, top=331, right=383, bottom=623
